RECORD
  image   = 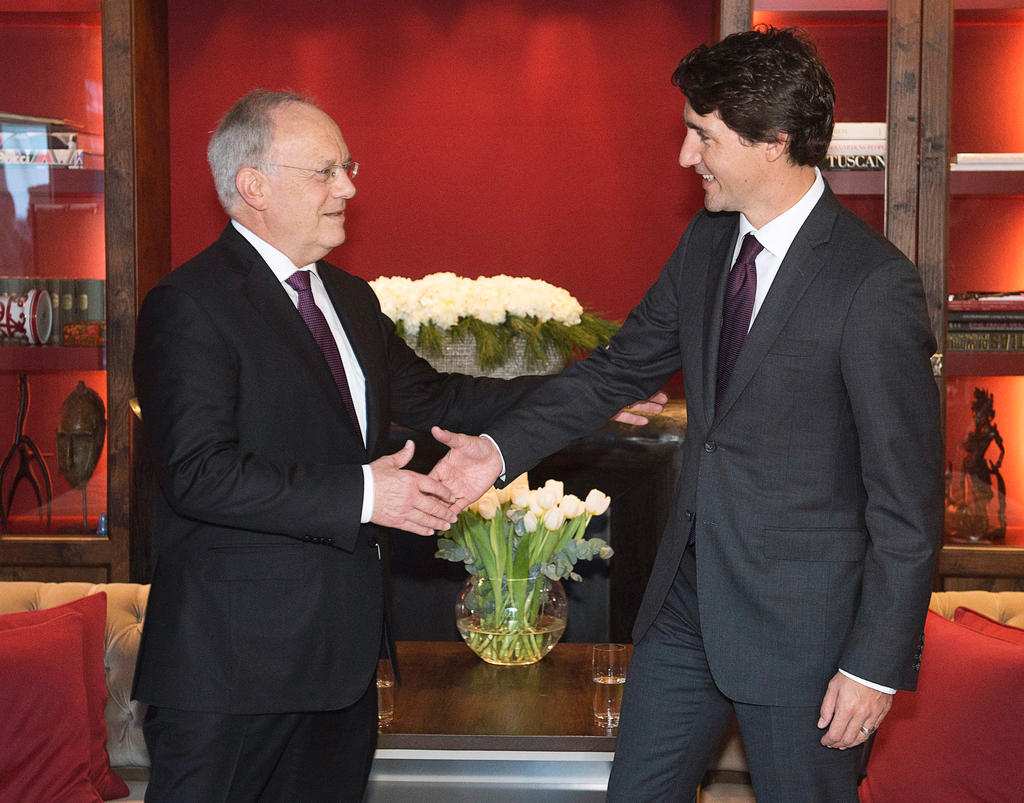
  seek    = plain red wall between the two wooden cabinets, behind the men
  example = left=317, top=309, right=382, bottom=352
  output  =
left=168, top=0, right=712, bottom=325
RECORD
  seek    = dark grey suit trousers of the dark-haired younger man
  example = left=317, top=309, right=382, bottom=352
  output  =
left=607, top=546, right=860, bottom=803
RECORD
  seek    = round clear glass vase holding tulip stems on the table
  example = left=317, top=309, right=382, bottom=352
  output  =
left=455, top=575, right=568, bottom=667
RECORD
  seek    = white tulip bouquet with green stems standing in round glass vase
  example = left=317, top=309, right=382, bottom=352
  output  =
left=435, top=475, right=612, bottom=664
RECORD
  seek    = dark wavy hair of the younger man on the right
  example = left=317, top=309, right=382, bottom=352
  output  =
left=672, top=26, right=836, bottom=166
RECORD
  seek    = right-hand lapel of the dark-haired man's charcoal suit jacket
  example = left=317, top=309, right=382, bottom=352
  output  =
left=715, top=185, right=839, bottom=419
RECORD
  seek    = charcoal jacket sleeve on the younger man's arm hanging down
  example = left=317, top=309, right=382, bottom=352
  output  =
left=840, top=254, right=943, bottom=688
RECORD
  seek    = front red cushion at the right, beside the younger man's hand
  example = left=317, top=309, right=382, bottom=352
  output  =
left=860, top=610, right=1024, bottom=803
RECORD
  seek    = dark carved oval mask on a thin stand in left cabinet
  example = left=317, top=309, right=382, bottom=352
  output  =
left=57, top=380, right=106, bottom=530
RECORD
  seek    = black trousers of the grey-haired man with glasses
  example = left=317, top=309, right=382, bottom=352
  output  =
left=143, top=680, right=377, bottom=803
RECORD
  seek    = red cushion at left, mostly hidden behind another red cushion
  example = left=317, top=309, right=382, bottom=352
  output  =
left=0, top=591, right=128, bottom=800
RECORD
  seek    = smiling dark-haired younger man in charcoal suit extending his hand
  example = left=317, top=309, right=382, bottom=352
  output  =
left=432, top=28, right=942, bottom=803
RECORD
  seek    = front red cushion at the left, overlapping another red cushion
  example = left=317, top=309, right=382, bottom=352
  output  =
left=0, top=611, right=102, bottom=803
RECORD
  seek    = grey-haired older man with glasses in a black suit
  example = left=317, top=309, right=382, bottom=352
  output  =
left=134, top=90, right=659, bottom=803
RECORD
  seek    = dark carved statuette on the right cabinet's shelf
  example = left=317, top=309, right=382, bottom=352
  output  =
left=953, top=387, right=1007, bottom=541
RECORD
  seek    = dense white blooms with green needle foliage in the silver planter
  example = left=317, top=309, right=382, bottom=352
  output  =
left=370, top=272, right=618, bottom=368
